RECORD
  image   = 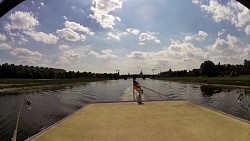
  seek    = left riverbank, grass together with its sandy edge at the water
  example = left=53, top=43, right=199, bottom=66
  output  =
left=0, top=78, right=109, bottom=92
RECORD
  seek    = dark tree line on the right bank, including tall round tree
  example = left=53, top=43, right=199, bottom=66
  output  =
left=159, top=59, right=250, bottom=77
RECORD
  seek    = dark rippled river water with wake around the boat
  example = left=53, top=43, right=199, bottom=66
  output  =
left=0, top=79, right=250, bottom=141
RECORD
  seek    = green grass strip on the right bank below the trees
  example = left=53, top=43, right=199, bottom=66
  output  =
left=158, top=75, right=250, bottom=86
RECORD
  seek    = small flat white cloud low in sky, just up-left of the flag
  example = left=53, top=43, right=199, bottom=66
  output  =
left=88, top=49, right=117, bottom=59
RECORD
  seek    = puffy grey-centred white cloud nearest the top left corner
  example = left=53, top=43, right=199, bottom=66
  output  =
left=4, top=11, right=39, bottom=31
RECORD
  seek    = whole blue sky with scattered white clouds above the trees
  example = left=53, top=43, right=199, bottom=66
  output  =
left=0, top=0, right=250, bottom=74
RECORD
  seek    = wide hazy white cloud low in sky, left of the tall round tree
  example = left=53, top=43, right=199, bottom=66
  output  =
left=127, top=40, right=206, bottom=69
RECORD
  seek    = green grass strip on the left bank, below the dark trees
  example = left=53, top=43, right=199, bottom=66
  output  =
left=0, top=78, right=110, bottom=89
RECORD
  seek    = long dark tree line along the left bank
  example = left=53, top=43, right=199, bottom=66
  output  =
left=0, top=63, right=119, bottom=79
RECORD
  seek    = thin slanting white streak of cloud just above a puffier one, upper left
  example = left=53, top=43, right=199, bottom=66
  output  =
left=64, top=21, right=94, bottom=35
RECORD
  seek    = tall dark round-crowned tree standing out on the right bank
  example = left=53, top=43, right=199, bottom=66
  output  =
left=200, top=60, right=217, bottom=77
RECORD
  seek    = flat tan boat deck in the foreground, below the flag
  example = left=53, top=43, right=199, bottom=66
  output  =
left=28, top=101, right=250, bottom=141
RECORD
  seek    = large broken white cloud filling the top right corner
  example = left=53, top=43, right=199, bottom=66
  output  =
left=192, top=0, right=250, bottom=32
